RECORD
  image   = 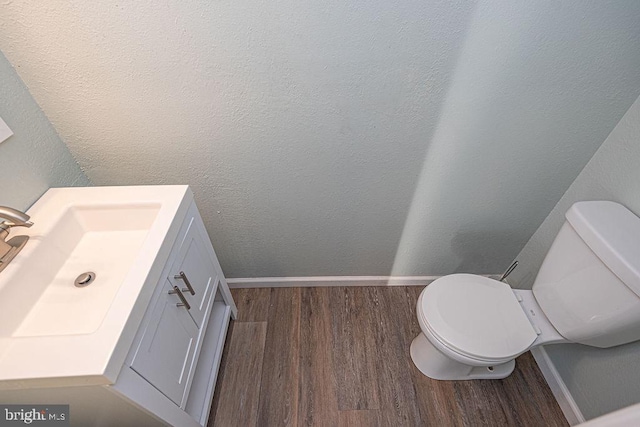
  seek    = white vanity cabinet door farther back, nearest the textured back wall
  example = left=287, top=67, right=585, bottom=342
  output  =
left=168, top=215, right=218, bottom=327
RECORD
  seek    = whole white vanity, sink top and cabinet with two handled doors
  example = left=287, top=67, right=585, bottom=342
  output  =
left=0, top=186, right=237, bottom=427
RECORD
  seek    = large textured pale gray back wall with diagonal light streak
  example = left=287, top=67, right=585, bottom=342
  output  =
left=0, top=0, right=640, bottom=277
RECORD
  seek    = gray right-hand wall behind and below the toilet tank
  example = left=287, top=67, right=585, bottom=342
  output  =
left=512, top=94, right=640, bottom=419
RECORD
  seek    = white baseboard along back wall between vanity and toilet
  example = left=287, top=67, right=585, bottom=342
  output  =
left=227, top=276, right=440, bottom=289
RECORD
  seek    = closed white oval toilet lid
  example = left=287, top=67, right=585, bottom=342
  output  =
left=418, top=274, right=537, bottom=360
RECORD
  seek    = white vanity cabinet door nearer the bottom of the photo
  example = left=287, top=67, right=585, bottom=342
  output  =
left=131, top=282, right=198, bottom=406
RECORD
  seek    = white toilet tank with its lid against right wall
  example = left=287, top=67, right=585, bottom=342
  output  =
left=533, top=201, right=640, bottom=347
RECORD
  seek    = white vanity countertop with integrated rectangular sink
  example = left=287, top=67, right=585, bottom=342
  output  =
left=0, top=186, right=193, bottom=388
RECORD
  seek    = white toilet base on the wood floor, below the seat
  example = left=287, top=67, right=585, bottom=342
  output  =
left=411, top=332, right=516, bottom=381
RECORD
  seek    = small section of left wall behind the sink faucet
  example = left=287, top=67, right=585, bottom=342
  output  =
left=0, top=52, right=89, bottom=210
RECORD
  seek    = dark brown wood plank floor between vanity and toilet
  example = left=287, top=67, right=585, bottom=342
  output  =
left=209, top=287, right=567, bottom=427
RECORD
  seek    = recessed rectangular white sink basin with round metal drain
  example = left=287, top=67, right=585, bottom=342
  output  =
left=0, top=201, right=160, bottom=337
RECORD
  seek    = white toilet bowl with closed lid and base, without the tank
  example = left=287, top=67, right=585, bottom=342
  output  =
left=411, top=274, right=566, bottom=380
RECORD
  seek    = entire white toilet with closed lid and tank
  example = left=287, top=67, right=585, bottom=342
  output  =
left=411, top=201, right=640, bottom=380
